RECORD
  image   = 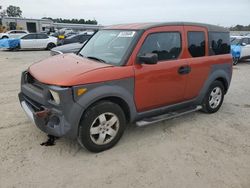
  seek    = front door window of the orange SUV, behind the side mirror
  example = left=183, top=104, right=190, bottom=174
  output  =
left=139, top=32, right=181, bottom=61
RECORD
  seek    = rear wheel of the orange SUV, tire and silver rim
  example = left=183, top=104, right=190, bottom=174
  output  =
left=202, top=80, right=225, bottom=114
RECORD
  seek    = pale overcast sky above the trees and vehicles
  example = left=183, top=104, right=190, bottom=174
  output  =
left=0, top=0, right=250, bottom=26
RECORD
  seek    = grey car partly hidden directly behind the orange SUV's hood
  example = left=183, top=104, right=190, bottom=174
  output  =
left=50, top=41, right=86, bottom=56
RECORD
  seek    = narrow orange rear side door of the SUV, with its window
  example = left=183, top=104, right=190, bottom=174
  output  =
left=184, top=26, right=212, bottom=100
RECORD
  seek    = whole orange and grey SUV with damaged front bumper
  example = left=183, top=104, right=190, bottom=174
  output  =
left=19, top=22, right=232, bottom=152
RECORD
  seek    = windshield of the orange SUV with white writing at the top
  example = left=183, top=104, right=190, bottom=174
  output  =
left=79, top=30, right=137, bottom=65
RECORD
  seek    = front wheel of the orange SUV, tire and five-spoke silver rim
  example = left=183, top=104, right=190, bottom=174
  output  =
left=78, top=101, right=126, bottom=152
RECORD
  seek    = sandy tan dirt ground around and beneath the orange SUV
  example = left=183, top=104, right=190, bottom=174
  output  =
left=0, top=51, right=250, bottom=188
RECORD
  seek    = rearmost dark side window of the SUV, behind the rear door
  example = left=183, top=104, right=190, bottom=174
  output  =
left=209, top=32, right=230, bottom=55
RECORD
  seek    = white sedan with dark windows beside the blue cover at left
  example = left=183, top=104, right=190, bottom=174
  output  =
left=19, top=33, right=57, bottom=50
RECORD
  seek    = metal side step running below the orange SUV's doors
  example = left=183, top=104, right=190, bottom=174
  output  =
left=136, top=106, right=202, bottom=127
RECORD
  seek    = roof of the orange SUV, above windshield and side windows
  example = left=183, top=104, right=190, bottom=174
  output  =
left=104, top=22, right=229, bottom=32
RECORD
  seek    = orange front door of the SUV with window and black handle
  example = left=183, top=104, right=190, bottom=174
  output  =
left=134, top=26, right=187, bottom=112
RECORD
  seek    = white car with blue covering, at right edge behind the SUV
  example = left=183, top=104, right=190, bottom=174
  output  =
left=230, top=36, right=250, bottom=65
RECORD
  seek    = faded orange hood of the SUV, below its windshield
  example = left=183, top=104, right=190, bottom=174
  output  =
left=28, top=54, right=113, bottom=86
